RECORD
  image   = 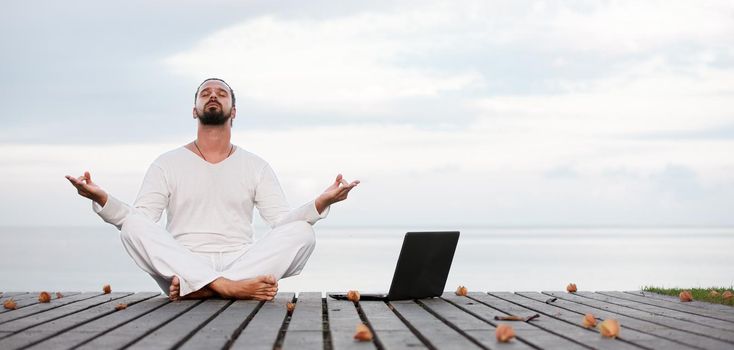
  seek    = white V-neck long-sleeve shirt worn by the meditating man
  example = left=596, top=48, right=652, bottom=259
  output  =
left=92, top=147, right=329, bottom=252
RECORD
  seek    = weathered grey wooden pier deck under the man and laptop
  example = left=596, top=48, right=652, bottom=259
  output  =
left=0, top=291, right=734, bottom=350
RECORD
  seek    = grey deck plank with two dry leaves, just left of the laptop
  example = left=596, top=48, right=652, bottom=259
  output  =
left=326, top=298, right=375, bottom=350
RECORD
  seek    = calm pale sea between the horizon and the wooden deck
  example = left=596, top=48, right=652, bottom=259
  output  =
left=0, top=225, right=734, bottom=292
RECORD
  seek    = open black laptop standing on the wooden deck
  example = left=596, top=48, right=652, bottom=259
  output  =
left=329, top=231, right=459, bottom=300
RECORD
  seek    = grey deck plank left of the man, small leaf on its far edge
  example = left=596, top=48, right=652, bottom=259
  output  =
left=30, top=293, right=169, bottom=350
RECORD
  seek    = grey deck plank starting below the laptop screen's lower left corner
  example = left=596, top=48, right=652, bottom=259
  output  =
left=390, top=301, right=480, bottom=349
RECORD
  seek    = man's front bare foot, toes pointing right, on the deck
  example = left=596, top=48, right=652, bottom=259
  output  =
left=209, top=275, right=278, bottom=300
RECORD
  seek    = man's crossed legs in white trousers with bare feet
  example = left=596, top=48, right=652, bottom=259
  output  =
left=121, top=213, right=315, bottom=300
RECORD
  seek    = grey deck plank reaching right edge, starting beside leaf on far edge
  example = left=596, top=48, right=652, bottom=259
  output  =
left=576, top=292, right=734, bottom=332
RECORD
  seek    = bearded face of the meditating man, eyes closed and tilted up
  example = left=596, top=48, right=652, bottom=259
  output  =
left=194, top=80, right=235, bottom=125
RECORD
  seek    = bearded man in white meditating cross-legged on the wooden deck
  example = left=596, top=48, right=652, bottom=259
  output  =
left=66, top=78, right=359, bottom=300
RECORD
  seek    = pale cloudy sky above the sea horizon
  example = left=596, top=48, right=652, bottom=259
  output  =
left=0, top=0, right=734, bottom=228
